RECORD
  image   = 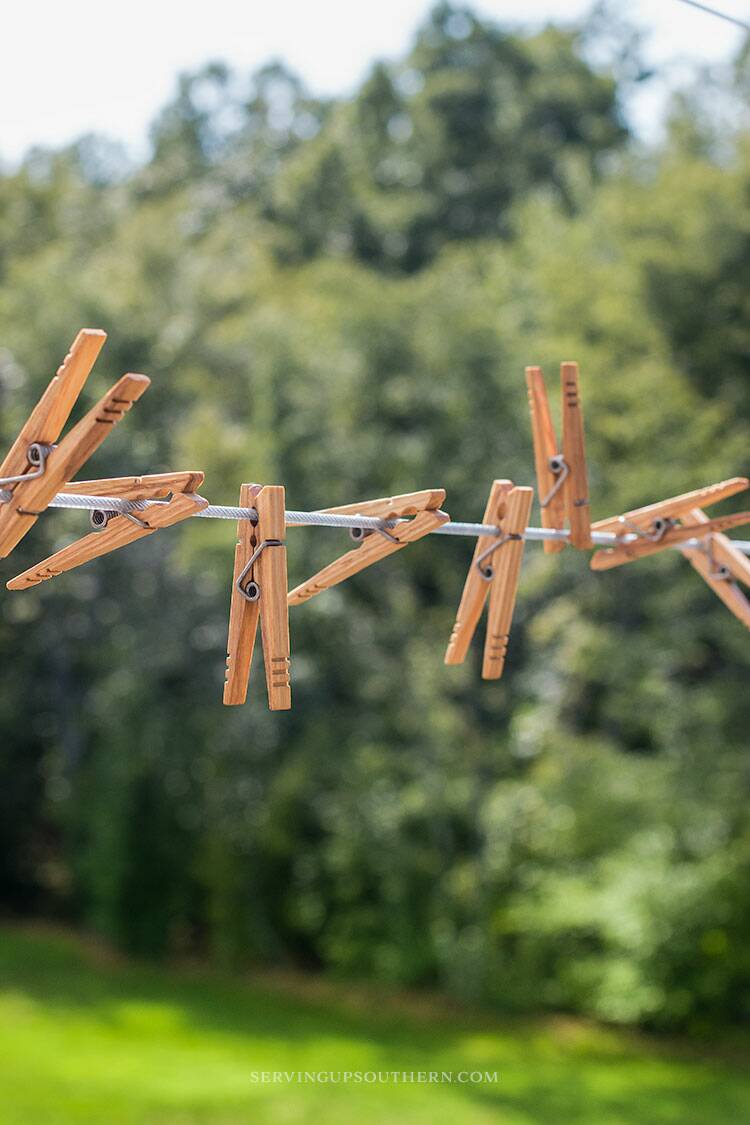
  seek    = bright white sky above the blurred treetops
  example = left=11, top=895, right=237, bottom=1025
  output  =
left=0, top=0, right=750, bottom=162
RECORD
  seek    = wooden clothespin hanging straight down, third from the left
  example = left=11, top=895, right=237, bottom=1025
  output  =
left=224, top=484, right=291, bottom=711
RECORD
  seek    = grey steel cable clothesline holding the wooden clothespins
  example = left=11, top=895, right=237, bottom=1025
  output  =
left=0, top=489, right=737, bottom=555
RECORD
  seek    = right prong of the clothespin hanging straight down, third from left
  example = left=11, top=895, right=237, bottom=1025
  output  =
left=254, top=485, right=291, bottom=711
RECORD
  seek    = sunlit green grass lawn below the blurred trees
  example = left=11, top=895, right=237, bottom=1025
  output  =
left=0, top=928, right=750, bottom=1125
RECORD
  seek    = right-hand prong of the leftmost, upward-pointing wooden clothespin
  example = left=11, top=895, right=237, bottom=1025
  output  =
left=0, top=375, right=151, bottom=558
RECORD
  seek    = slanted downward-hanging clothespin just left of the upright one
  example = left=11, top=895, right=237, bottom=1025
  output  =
left=445, top=480, right=534, bottom=680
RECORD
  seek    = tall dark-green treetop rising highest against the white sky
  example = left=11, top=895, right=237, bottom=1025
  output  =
left=271, top=3, right=626, bottom=271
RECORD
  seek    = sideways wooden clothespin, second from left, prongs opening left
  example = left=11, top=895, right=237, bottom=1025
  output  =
left=7, top=471, right=208, bottom=590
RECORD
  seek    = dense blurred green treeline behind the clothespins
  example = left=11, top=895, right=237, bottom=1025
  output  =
left=0, top=6, right=750, bottom=1026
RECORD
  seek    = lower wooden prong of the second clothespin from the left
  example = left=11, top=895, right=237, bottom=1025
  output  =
left=8, top=493, right=208, bottom=590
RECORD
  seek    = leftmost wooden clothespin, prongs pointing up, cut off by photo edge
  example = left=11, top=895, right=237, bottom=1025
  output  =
left=0, top=329, right=151, bottom=558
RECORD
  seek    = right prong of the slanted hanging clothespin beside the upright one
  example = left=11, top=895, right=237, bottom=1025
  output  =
left=481, top=488, right=534, bottom=680
